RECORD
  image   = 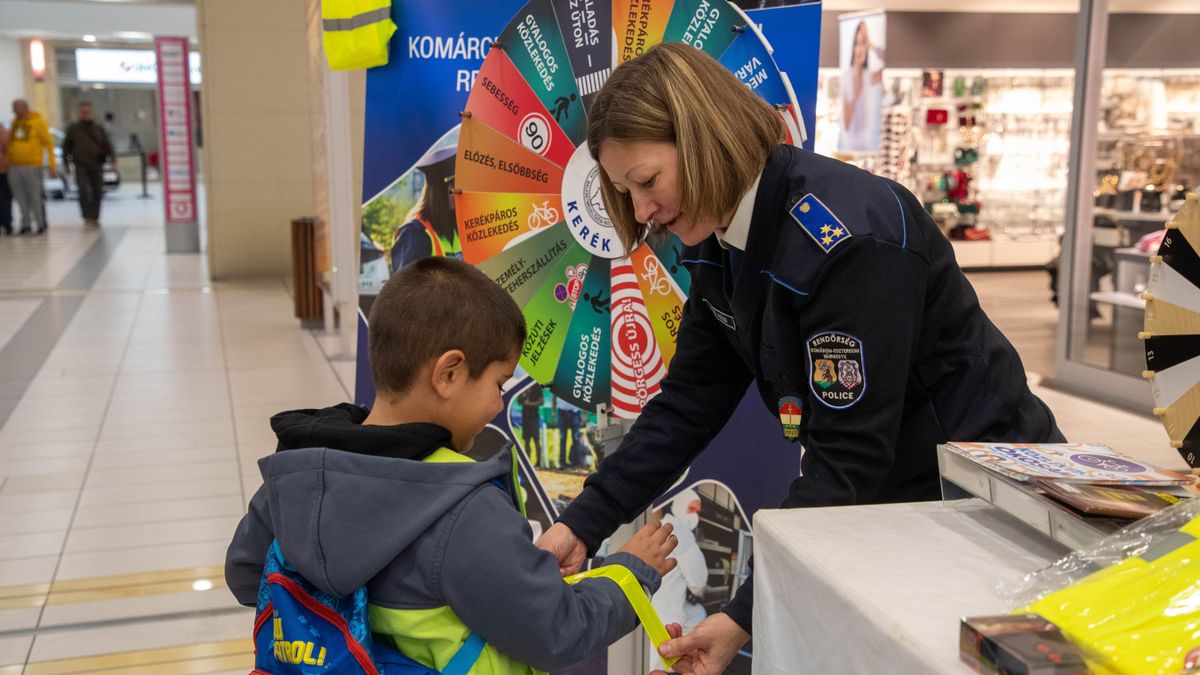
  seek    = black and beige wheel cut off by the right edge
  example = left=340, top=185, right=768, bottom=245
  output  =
left=1140, top=193, right=1200, bottom=472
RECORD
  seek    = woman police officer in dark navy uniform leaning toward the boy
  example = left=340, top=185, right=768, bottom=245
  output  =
left=538, top=43, right=1063, bottom=674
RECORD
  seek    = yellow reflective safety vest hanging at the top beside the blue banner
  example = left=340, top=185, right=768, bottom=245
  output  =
left=320, top=0, right=396, bottom=71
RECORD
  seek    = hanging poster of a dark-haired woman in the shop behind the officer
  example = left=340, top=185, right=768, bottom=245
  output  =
left=838, top=11, right=887, bottom=153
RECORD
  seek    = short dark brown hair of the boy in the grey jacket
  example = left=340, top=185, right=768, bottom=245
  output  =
left=367, top=257, right=526, bottom=394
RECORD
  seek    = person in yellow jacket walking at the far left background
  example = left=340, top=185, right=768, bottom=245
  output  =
left=6, top=98, right=59, bottom=234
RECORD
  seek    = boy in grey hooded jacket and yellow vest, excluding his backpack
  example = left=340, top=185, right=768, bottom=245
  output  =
left=226, top=257, right=676, bottom=675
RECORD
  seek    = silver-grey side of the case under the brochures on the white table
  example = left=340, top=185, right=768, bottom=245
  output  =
left=937, top=446, right=1124, bottom=550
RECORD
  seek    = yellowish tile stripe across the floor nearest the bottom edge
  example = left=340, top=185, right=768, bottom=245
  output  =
left=22, top=638, right=254, bottom=675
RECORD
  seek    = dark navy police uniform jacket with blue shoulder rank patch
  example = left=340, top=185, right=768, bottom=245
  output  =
left=560, top=145, right=1064, bottom=632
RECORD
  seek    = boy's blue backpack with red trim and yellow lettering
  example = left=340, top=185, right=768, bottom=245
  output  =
left=251, top=540, right=484, bottom=675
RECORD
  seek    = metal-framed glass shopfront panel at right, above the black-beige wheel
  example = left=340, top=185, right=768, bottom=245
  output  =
left=1057, top=0, right=1200, bottom=412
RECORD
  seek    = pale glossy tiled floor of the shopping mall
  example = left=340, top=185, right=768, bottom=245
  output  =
left=0, top=184, right=1180, bottom=675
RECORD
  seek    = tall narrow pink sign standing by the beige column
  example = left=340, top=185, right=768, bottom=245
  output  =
left=154, top=37, right=197, bottom=223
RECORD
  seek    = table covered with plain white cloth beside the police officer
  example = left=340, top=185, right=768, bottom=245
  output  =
left=754, top=500, right=1068, bottom=675
